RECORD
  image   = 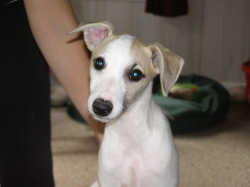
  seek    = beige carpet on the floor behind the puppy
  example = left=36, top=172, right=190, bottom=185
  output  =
left=52, top=103, right=250, bottom=187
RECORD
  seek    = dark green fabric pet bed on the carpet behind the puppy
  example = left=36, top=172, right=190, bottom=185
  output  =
left=153, top=75, right=230, bottom=133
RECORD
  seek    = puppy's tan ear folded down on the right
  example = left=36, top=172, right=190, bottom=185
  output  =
left=149, top=43, right=184, bottom=96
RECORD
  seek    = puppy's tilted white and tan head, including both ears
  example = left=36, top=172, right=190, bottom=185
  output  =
left=70, top=22, right=184, bottom=122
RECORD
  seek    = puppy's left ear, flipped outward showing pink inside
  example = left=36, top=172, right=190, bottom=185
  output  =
left=68, top=21, right=113, bottom=51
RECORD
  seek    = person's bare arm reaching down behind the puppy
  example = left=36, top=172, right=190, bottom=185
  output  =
left=24, top=0, right=104, bottom=140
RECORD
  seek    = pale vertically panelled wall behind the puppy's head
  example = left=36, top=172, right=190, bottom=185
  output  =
left=71, top=0, right=250, bottom=82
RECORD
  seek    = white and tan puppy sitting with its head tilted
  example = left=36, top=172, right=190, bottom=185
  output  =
left=71, top=22, right=183, bottom=187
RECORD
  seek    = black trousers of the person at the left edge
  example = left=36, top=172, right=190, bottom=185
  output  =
left=0, top=1, right=54, bottom=187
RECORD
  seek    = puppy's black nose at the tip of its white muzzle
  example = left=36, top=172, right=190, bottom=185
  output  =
left=92, top=98, right=113, bottom=117
